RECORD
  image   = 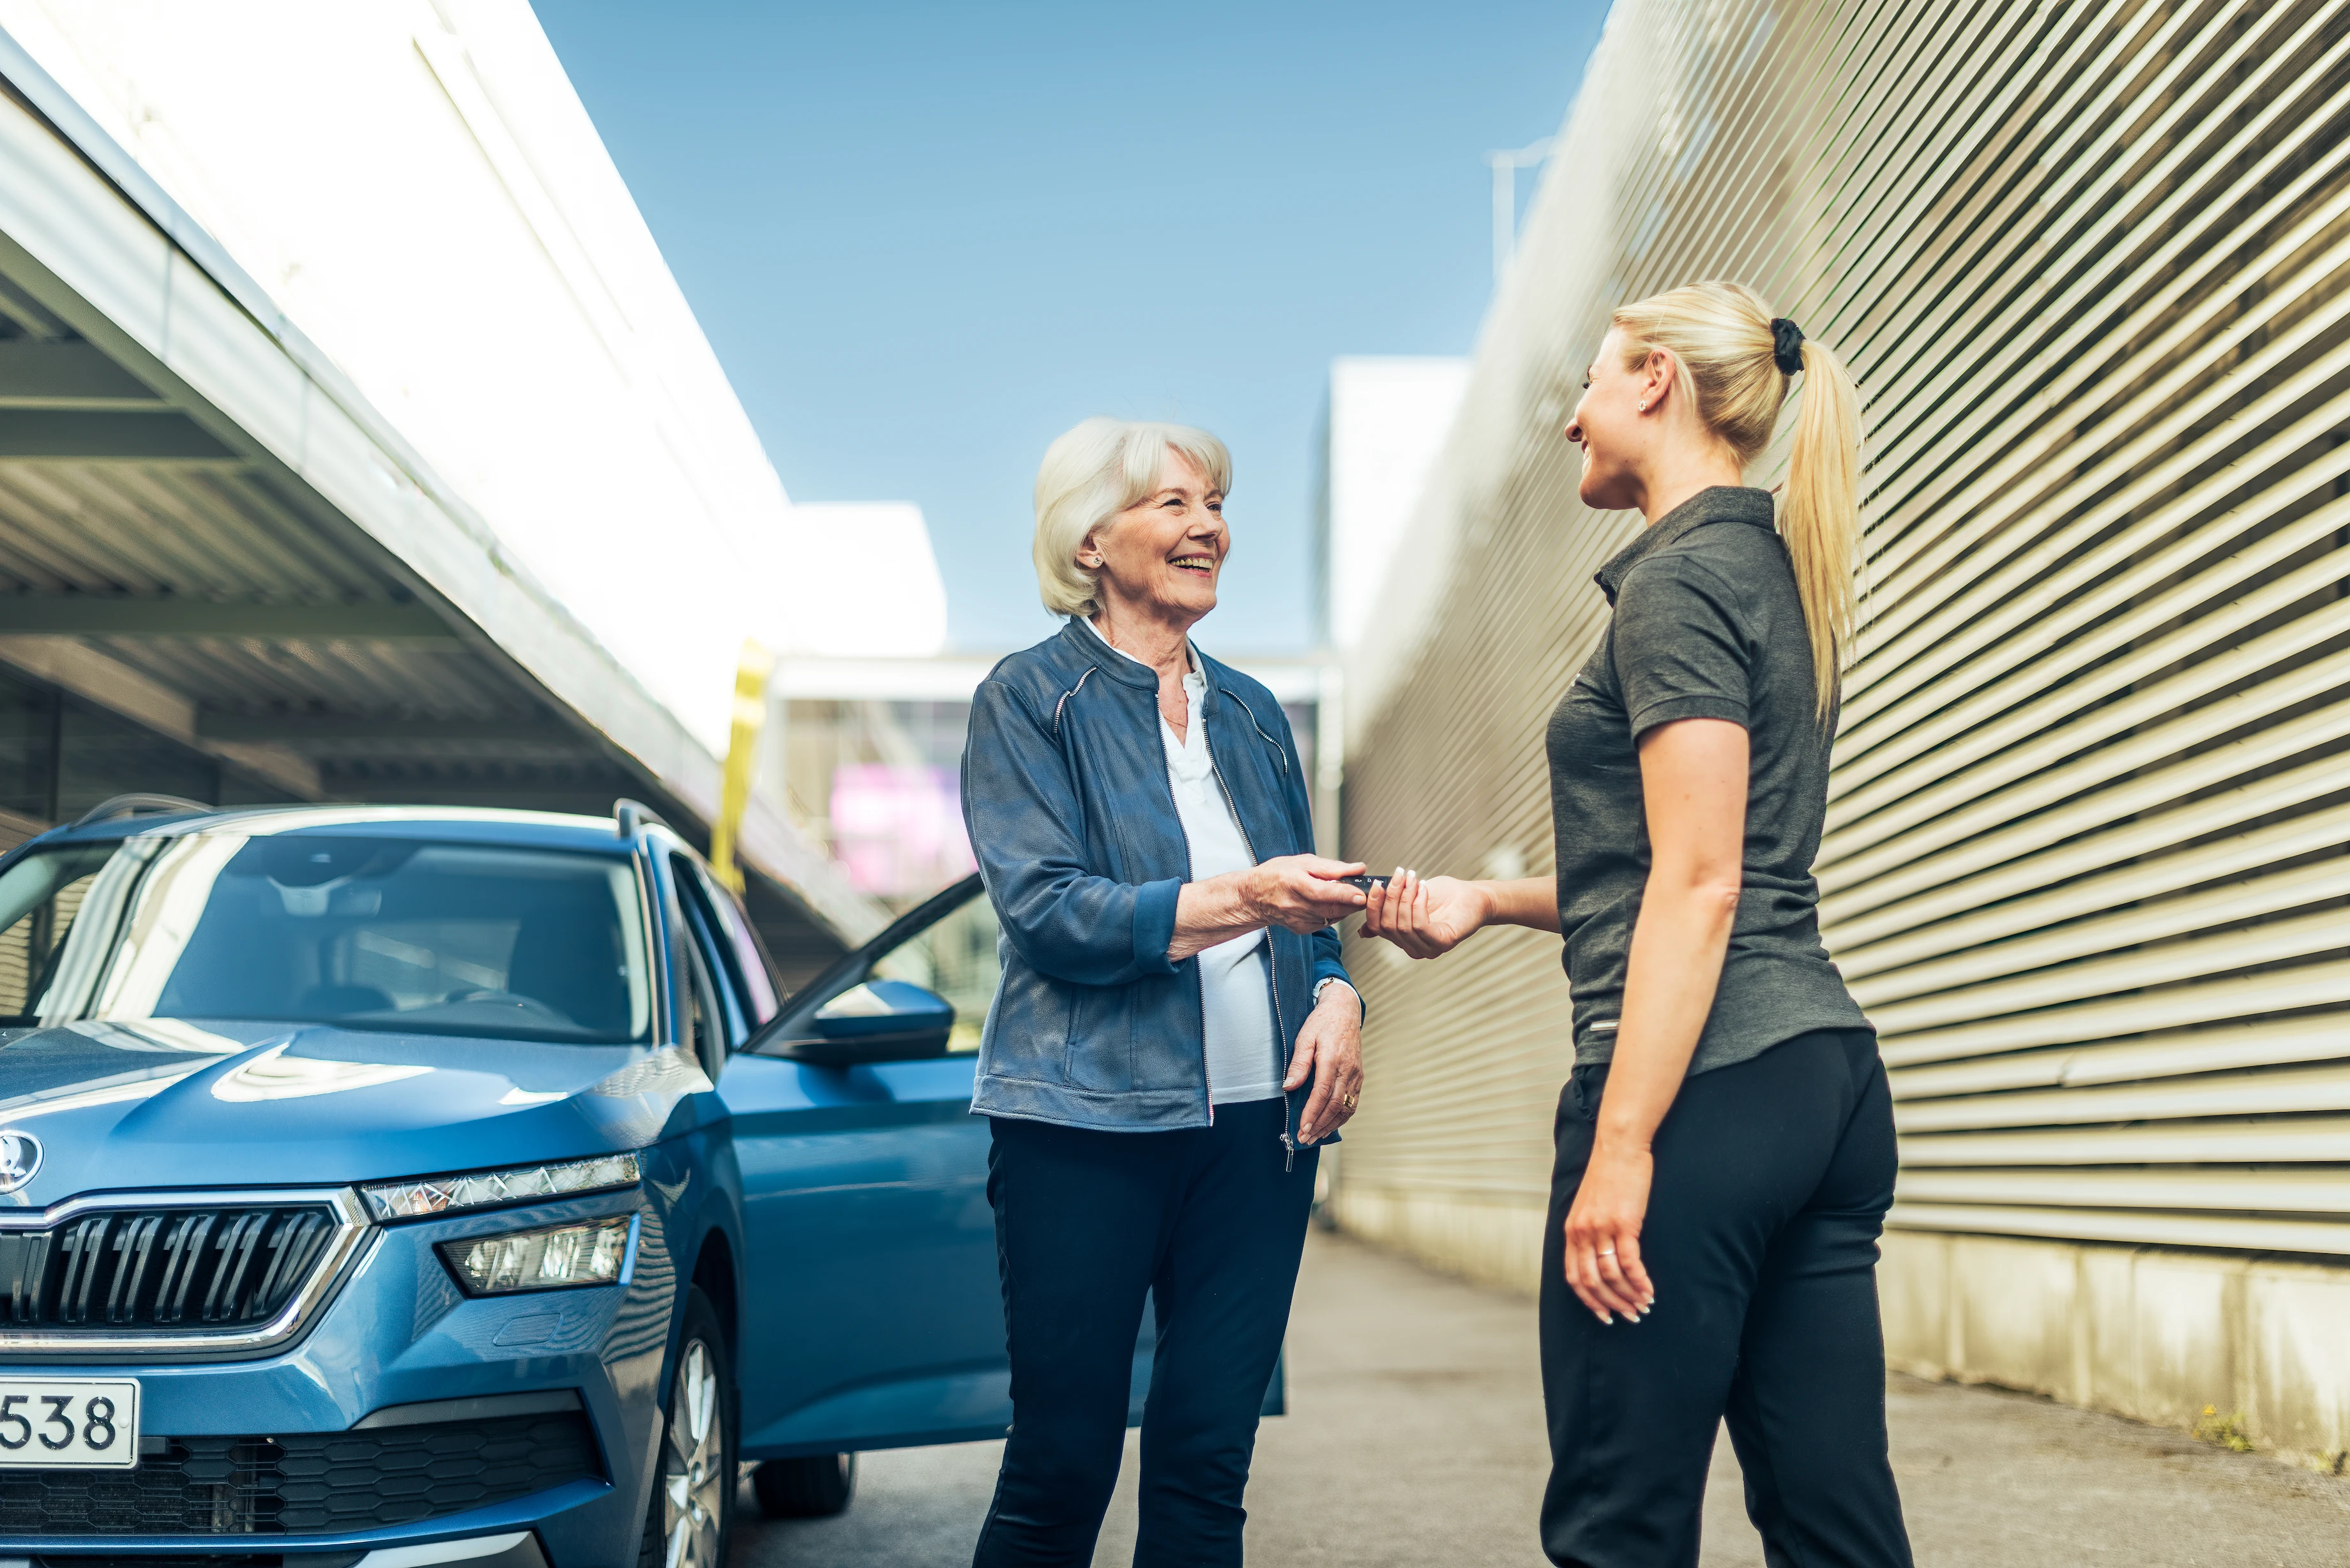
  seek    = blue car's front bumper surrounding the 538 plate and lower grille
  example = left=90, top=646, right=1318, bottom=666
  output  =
left=0, top=1189, right=677, bottom=1568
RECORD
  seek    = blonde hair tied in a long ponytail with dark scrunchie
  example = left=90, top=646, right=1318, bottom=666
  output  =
left=1610, top=282, right=1861, bottom=724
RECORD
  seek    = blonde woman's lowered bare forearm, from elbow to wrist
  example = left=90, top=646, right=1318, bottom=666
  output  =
left=1598, top=875, right=1739, bottom=1152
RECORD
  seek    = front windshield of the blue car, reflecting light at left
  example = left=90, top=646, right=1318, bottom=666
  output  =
left=0, top=832, right=653, bottom=1044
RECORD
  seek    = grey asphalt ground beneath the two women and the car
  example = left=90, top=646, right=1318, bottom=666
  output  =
left=731, top=1232, right=2350, bottom=1568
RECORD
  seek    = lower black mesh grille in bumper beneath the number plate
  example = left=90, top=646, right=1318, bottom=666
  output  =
left=0, top=1410, right=604, bottom=1537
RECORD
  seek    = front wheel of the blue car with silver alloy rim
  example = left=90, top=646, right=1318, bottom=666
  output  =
left=637, top=1288, right=736, bottom=1568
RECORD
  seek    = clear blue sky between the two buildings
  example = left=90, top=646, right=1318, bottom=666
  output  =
left=538, top=0, right=1607, bottom=651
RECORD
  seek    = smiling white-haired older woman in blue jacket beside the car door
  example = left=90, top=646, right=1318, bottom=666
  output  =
left=964, top=418, right=1363, bottom=1568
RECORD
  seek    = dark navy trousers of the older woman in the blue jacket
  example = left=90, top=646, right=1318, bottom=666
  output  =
left=973, top=1100, right=1316, bottom=1568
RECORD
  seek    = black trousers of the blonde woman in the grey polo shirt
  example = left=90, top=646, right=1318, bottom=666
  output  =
left=1542, top=1032, right=1911, bottom=1568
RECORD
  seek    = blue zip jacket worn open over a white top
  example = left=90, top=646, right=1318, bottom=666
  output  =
left=964, top=621, right=1347, bottom=1150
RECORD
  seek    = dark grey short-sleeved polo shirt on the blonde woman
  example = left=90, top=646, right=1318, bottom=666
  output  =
left=1549, top=486, right=1869, bottom=1074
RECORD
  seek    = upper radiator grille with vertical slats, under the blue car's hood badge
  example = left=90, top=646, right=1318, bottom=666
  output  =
left=0, top=1203, right=341, bottom=1333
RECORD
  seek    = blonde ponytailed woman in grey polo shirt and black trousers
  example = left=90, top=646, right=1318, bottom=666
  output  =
left=1365, top=282, right=1911, bottom=1568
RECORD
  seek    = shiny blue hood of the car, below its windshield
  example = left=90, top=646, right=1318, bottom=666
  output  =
left=0, top=1018, right=715, bottom=1210
